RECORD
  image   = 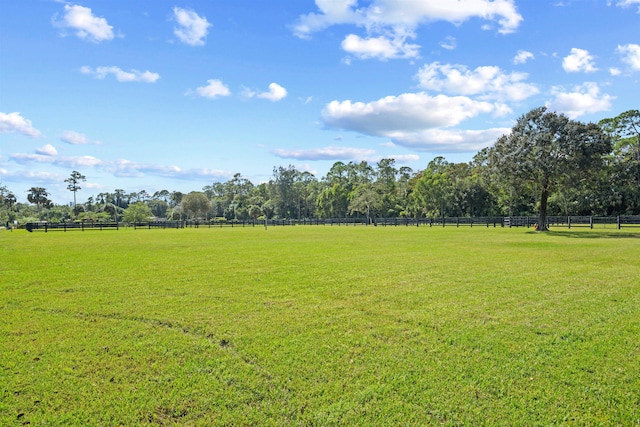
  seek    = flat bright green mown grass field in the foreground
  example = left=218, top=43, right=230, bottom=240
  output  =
left=0, top=226, right=640, bottom=426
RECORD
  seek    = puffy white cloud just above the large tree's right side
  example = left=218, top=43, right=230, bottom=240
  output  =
left=547, top=82, right=615, bottom=119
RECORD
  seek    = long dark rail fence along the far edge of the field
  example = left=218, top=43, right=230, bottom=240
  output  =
left=26, top=215, right=640, bottom=233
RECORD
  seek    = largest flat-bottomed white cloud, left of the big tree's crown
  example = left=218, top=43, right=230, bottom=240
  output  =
left=322, top=92, right=508, bottom=152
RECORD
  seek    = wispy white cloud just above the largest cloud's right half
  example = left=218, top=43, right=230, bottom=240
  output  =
left=416, top=62, right=539, bottom=101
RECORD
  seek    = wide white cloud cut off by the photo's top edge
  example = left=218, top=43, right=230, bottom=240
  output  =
left=293, top=0, right=522, bottom=38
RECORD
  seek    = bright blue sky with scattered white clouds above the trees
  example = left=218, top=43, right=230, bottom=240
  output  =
left=0, top=0, right=640, bottom=203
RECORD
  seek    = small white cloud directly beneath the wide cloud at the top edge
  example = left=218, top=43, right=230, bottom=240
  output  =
left=342, top=34, right=420, bottom=61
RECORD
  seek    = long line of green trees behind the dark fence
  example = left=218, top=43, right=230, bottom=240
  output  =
left=0, top=107, right=640, bottom=229
